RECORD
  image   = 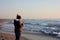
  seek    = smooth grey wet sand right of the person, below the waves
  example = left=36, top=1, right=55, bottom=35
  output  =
left=22, top=33, right=60, bottom=40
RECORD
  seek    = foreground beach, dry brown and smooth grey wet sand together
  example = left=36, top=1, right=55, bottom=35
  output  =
left=0, top=19, right=60, bottom=40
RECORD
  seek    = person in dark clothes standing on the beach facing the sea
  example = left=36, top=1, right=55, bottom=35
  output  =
left=14, top=14, right=23, bottom=40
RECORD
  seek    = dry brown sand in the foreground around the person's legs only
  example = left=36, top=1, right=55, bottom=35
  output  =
left=0, top=33, right=28, bottom=40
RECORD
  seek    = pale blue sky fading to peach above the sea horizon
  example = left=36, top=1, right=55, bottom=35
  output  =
left=0, top=0, right=60, bottom=19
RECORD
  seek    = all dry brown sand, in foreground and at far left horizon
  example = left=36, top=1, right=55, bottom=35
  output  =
left=0, top=19, right=28, bottom=40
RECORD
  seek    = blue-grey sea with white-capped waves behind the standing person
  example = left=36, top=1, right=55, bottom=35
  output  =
left=0, top=19, right=60, bottom=35
